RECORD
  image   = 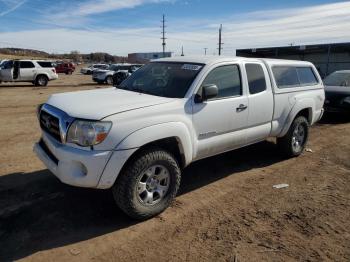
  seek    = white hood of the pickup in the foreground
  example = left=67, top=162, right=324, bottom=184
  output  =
left=47, top=87, right=175, bottom=120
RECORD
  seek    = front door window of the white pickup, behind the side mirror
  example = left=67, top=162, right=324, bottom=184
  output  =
left=202, top=65, right=242, bottom=99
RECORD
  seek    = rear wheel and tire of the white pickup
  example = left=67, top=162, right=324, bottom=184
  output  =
left=277, top=116, right=309, bottom=157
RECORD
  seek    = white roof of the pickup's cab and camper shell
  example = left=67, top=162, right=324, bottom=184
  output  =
left=156, top=55, right=311, bottom=65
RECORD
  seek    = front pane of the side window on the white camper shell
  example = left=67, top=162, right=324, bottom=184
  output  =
left=272, top=66, right=300, bottom=88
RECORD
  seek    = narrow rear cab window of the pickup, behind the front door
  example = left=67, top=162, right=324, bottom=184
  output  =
left=245, top=64, right=266, bottom=95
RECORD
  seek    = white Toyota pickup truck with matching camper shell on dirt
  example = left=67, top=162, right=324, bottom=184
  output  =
left=34, top=56, right=325, bottom=219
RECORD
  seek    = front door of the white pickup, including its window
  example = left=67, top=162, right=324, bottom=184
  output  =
left=192, top=64, right=248, bottom=159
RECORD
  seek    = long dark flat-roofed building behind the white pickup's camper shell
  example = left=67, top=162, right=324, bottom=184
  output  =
left=236, top=42, right=350, bottom=77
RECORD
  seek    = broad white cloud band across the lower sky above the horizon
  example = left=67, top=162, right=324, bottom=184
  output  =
left=0, top=2, right=350, bottom=55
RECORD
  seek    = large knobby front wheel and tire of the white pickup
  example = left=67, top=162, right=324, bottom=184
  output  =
left=112, top=148, right=181, bottom=220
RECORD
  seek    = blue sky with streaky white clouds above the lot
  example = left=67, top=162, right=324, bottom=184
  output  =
left=0, top=0, right=350, bottom=56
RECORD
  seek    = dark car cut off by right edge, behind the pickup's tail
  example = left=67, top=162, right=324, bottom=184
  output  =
left=324, top=70, right=350, bottom=113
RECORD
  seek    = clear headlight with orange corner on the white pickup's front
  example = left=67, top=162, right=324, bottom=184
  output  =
left=67, top=120, right=112, bottom=146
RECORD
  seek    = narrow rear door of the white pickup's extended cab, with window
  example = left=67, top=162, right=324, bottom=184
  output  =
left=244, top=62, right=274, bottom=143
